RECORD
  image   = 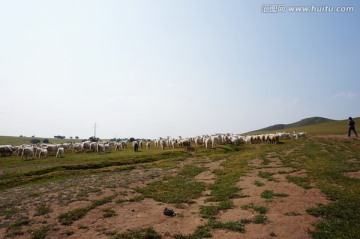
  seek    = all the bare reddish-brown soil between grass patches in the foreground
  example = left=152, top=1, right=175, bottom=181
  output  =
left=0, top=152, right=330, bottom=239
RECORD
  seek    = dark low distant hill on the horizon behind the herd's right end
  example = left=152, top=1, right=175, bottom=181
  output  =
left=248, top=117, right=335, bottom=133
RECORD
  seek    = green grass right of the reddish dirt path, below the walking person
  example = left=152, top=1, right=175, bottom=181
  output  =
left=282, top=138, right=360, bottom=239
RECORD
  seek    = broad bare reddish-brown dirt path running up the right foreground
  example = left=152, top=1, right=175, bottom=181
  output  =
left=214, top=156, right=328, bottom=239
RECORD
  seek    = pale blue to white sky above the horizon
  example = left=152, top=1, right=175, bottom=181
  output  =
left=0, top=0, right=360, bottom=138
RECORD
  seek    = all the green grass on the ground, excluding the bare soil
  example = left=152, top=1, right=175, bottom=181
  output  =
left=0, top=133, right=360, bottom=239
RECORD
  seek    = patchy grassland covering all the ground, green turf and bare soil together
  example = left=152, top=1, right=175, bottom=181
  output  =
left=0, top=127, right=360, bottom=239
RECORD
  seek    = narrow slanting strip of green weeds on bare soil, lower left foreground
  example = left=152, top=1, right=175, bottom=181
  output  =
left=58, top=195, right=116, bottom=226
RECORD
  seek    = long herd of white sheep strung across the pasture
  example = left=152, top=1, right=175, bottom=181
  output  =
left=0, top=132, right=306, bottom=159
